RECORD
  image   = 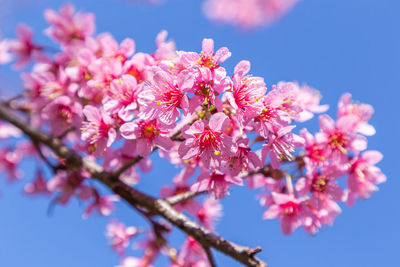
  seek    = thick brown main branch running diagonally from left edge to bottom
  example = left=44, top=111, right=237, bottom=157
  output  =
left=0, top=103, right=268, bottom=267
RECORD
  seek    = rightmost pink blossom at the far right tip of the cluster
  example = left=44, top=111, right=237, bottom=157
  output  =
left=347, top=150, right=386, bottom=206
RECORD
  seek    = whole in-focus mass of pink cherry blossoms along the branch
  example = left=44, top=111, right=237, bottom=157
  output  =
left=0, top=1, right=386, bottom=267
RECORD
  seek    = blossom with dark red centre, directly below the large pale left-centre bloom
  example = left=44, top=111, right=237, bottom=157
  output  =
left=120, top=119, right=173, bottom=157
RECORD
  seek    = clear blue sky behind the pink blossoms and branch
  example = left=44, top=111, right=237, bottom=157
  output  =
left=0, top=0, right=400, bottom=267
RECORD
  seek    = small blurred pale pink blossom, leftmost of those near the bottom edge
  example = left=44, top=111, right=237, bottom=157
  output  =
left=106, top=220, right=138, bottom=256
